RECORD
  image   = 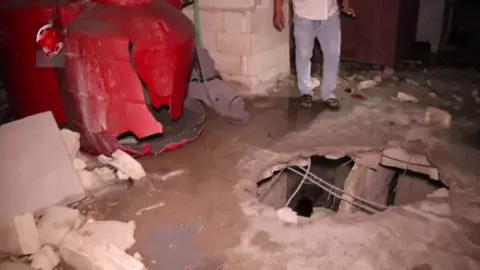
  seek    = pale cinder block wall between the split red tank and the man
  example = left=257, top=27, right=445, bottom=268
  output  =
left=184, top=0, right=290, bottom=94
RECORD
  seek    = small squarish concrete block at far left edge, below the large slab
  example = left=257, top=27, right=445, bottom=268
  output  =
left=0, top=213, right=41, bottom=255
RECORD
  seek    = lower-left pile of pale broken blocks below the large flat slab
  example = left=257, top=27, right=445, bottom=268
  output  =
left=0, top=206, right=146, bottom=270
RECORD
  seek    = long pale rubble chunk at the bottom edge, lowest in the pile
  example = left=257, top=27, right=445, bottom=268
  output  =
left=59, top=231, right=146, bottom=270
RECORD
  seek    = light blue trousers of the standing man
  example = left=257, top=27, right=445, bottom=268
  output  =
left=293, top=13, right=341, bottom=100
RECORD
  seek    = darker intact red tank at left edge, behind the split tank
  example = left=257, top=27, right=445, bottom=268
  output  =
left=0, top=0, right=86, bottom=124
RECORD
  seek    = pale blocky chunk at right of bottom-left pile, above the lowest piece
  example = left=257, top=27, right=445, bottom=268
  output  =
left=78, top=220, right=135, bottom=250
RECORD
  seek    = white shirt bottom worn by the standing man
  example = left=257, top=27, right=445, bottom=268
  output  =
left=293, top=0, right=338, bottom=20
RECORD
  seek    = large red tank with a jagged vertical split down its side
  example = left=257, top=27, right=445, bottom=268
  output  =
left=64, top=0, right=195, bottom=156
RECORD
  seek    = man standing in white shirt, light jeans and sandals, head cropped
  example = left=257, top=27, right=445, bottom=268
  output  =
left=273, top=0, right=355, bottom=110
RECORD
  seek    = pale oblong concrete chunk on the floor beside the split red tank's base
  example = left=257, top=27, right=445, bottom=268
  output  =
left=98, top=149, right=146, bottom=180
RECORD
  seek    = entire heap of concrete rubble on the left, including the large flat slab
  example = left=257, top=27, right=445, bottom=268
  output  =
left=0, top=112, right=146, bottom=270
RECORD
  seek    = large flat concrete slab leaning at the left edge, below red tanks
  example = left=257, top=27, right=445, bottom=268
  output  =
left=0, top=112, right=85, bottom=220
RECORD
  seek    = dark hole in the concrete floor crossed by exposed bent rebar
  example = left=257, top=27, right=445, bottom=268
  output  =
left=257, top=156, right=448, bottom=218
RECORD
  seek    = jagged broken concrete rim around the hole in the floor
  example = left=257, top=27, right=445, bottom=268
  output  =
left=234, top=146, right=449, bottom=224
